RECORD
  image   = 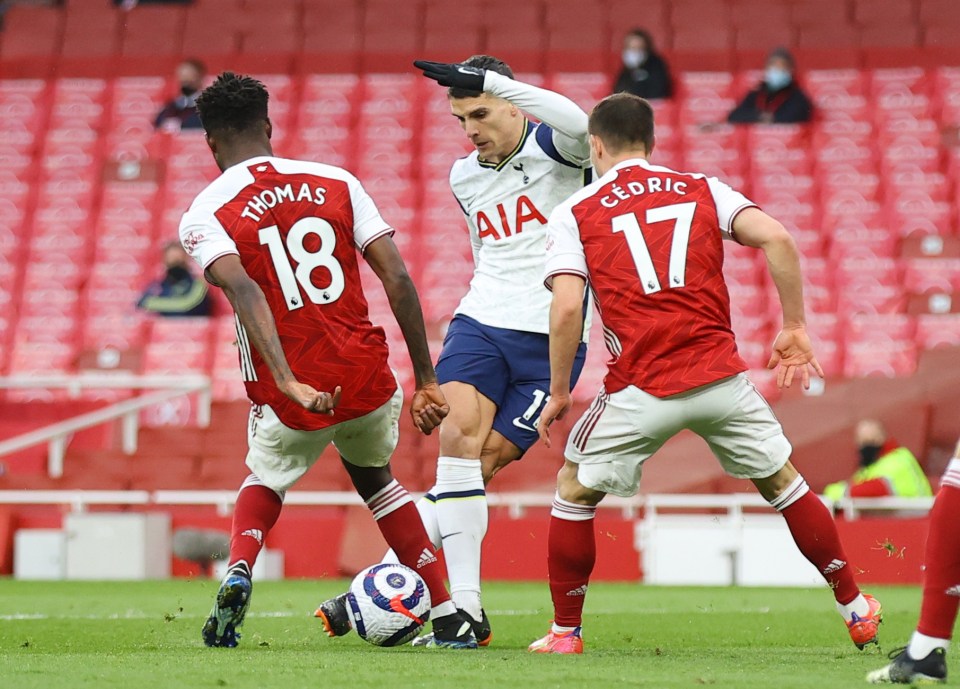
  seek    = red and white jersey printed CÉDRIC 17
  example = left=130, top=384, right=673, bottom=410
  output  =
left=546, top=155, right=755, bottom=397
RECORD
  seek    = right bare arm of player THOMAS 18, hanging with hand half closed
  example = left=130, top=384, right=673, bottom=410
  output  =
left=363, top=235, right=450, bottom=435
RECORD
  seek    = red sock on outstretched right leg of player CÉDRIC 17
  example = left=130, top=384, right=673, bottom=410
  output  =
left=770, top=476, right=860, bottom=605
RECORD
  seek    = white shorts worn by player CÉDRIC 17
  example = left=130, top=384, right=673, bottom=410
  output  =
left=565, top=373, right=793, bottom=497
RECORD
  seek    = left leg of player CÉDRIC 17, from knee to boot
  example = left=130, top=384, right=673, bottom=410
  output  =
left=528, top=460, right=605, bottom=653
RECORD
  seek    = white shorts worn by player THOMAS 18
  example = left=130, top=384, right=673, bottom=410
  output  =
left=247, top=385, right=403, bottom=492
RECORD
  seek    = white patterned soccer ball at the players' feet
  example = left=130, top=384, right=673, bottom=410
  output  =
left=347, top=564, right=431, bottom=646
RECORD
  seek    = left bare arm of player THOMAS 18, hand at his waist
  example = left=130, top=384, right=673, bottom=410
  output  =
left=206, top=254, right=340, bottom=414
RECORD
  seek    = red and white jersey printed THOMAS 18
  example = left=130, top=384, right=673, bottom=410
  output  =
left=180, top=157, right=397, bottom=430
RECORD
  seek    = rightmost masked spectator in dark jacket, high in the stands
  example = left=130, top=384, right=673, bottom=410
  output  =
left=727, top=48, right=813, bottom=124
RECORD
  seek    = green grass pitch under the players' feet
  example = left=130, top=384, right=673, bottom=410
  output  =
left=0, top=580, right=919, bottom=689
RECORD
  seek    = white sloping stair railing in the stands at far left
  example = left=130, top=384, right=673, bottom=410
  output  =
left=0, top=373, right=211, bottom=478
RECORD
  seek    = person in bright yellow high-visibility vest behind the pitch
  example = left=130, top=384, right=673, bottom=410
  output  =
left=823, top=419, right=933, bottom=500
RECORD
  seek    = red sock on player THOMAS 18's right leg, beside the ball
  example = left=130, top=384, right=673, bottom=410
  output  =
left=367, top=480, right=450, bottom=607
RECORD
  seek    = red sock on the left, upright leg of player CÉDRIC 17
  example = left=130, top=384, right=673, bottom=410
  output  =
left=547, top=496, right=597, bottom=627
